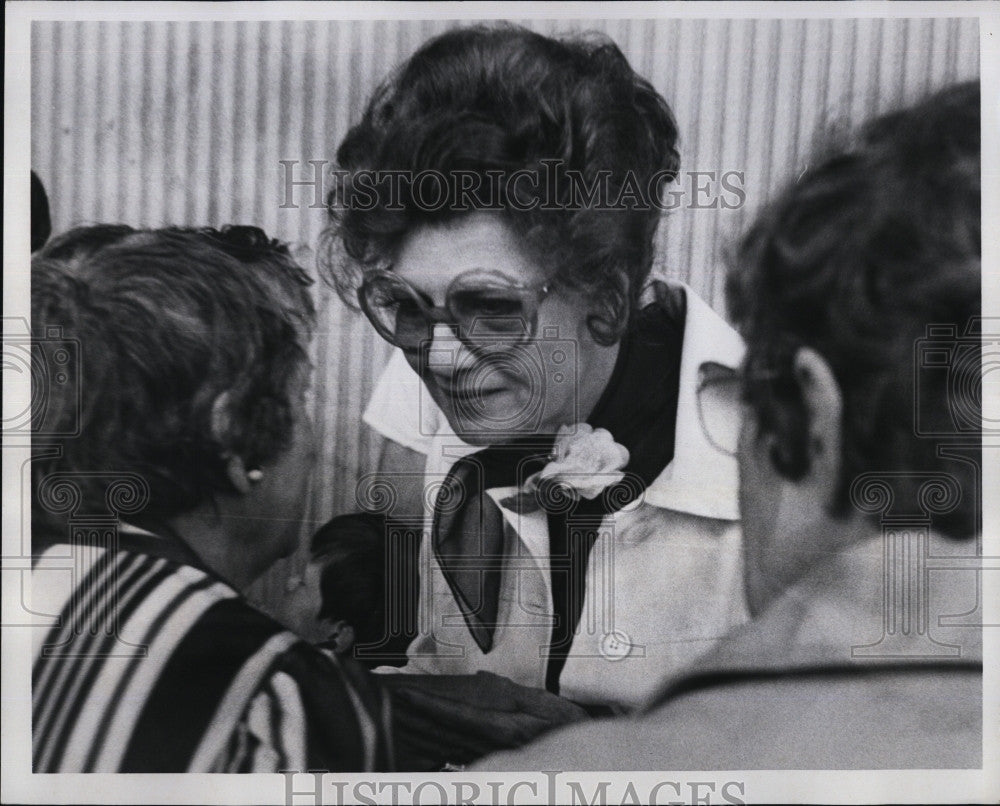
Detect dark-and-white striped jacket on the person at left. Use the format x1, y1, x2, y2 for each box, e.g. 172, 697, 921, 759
32, 530, 391, 773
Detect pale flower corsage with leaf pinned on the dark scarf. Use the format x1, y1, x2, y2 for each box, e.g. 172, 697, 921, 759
500, 423, 629, 513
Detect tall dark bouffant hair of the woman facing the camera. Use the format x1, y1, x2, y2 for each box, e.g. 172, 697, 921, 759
321, 25, 679, 344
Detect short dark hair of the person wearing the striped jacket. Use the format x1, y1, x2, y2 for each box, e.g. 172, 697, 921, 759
31, 225, 315, 522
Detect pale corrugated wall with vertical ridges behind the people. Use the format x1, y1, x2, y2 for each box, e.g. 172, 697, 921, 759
31, 19, 979, 602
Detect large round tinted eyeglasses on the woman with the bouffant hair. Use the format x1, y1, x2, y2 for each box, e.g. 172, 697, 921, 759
358, 270, 552, 351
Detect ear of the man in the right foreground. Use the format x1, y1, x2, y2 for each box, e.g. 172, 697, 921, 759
793, 347, 844, 505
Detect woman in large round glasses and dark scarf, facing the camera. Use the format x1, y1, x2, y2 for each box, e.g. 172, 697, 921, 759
326, 26, 745, 728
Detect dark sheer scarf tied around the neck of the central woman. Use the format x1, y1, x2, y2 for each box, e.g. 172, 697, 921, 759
431, 284, 686, 693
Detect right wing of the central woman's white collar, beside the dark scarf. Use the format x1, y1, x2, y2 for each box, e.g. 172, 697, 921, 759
645, 281, 745, 521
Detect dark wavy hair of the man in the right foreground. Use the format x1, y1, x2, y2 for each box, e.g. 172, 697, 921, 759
727, 83, 981, 537
